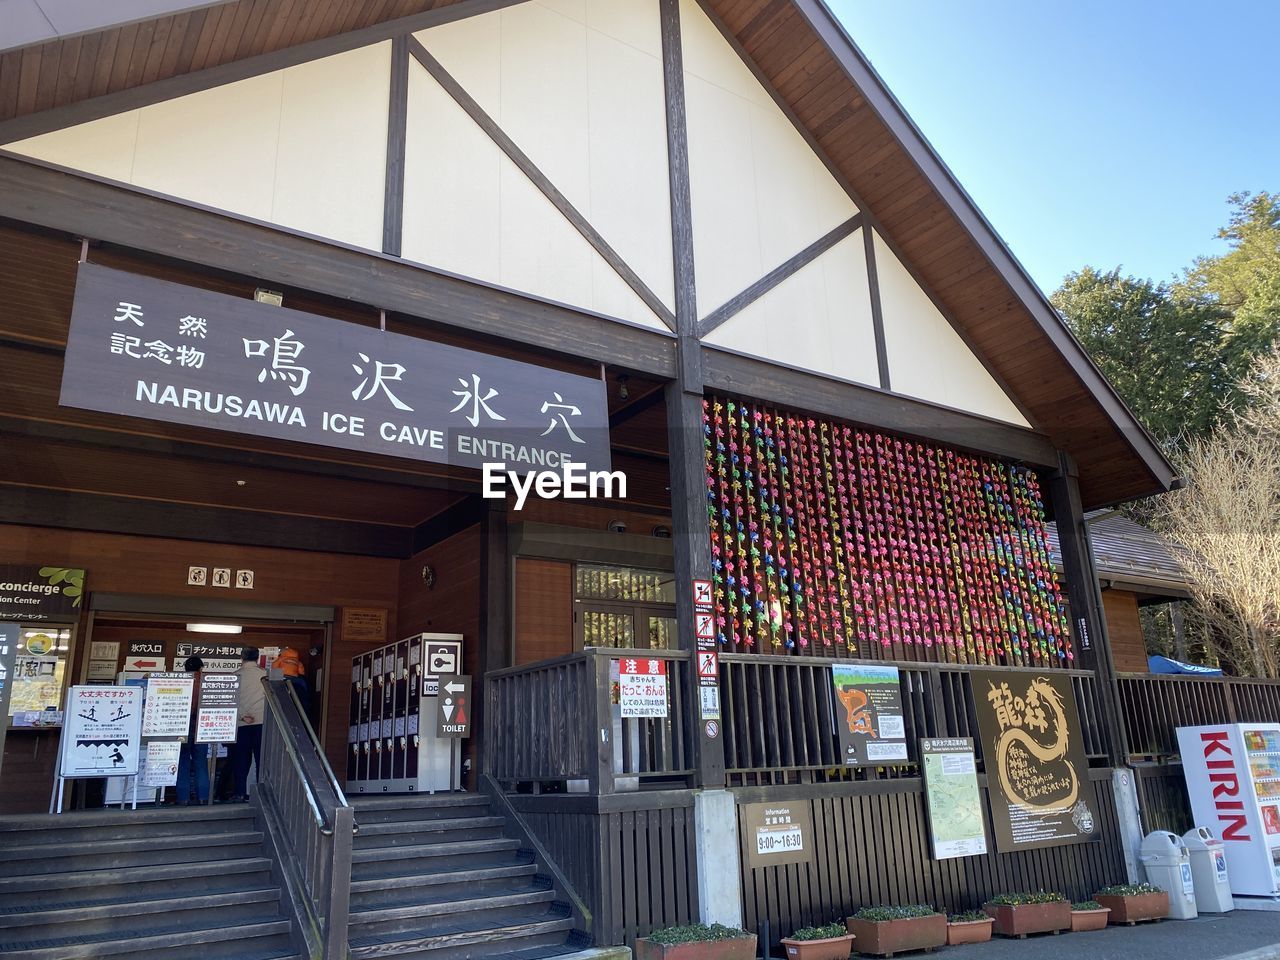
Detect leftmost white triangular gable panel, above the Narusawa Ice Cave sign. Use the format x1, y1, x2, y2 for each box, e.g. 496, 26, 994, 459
8, 44, 390, 250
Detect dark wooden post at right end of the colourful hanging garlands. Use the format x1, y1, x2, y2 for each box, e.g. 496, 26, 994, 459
1048, 452, 1129, 767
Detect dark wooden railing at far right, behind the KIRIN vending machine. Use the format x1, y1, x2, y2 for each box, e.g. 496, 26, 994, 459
1117, 673, 1280, 762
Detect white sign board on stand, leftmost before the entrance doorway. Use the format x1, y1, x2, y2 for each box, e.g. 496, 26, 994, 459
59, 686, 142, 777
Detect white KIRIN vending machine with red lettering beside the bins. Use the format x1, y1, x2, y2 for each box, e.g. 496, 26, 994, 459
1178, 723, 1280, 897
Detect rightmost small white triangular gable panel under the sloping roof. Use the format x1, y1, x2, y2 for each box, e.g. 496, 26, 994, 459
876, 234, 1029, 426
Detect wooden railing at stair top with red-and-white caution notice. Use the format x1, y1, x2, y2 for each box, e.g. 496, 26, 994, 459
485, 648, 692, 794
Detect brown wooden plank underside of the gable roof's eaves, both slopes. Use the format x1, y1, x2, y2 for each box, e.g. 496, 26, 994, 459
0, 0, 1175, 508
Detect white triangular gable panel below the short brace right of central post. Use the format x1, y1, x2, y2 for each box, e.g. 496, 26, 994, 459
705, 230, 879, 385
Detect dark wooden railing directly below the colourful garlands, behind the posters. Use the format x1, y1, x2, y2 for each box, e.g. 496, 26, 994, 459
721, 654, 1107, 786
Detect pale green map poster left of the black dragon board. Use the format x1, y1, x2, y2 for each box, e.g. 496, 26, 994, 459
920, 737, 987, 860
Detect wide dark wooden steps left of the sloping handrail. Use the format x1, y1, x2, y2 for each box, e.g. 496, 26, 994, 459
0, 805, 296, 960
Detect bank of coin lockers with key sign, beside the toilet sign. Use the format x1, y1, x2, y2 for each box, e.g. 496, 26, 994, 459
347, 634, 462, 794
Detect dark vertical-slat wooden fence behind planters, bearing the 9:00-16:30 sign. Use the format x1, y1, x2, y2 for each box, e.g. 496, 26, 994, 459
735, 768, 1125, 950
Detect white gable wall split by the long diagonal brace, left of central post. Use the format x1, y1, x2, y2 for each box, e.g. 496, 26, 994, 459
417, 0, 675, 326
